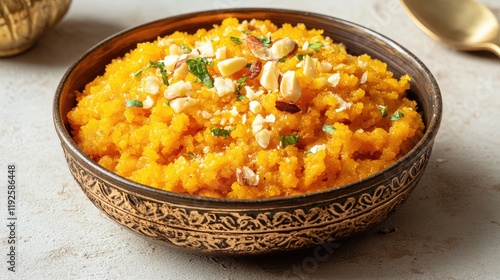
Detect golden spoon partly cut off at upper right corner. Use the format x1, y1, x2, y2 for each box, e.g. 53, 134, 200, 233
401, 0, 500, 57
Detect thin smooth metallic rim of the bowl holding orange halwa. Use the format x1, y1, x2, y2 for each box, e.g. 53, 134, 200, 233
52, 8, 443, 208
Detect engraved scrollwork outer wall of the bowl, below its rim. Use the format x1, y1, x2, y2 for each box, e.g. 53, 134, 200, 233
61, 149, 430, 254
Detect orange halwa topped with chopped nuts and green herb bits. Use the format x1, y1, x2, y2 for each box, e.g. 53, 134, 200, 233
68, 18, 424, 199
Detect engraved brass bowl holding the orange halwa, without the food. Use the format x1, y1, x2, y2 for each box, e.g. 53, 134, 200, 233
53, 8, 442, 255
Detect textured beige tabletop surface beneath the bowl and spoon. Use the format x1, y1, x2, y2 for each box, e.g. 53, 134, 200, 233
0, 0, 500, 279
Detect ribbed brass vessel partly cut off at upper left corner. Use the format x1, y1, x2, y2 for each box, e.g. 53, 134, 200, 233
0, 0, 71, 57
